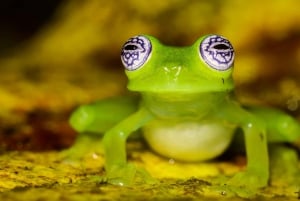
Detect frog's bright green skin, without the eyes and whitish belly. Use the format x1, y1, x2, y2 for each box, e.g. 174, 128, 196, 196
70, 36, 300, 188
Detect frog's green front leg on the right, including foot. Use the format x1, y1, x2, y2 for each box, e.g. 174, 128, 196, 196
217, 102, 269, 189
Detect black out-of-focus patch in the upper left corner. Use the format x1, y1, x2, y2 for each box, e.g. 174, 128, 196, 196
0, 0, 62, 54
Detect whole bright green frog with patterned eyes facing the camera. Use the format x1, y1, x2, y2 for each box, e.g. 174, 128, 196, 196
70, 35, 300, 188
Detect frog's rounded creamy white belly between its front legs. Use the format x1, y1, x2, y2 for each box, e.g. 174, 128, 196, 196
143, 121, 234, 162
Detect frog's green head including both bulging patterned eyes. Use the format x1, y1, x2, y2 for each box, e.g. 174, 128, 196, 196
121, 35, 234, 93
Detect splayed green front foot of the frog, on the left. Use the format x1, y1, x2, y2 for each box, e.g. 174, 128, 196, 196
100, 163, 157, 186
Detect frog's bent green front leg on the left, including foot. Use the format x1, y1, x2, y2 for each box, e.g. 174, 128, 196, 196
102, 108, 153, 186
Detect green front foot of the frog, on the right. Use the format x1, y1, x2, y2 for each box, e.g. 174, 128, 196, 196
226, 170, 269, 189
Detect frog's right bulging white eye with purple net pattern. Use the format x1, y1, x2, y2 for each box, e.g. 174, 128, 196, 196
199, 35, 234, 71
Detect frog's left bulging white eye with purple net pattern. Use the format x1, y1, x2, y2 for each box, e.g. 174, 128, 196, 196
121, 36, 152, 71
